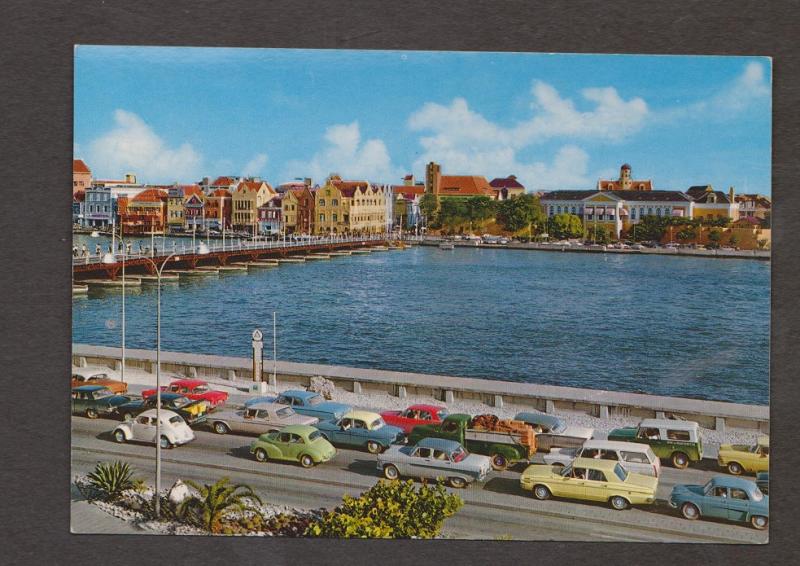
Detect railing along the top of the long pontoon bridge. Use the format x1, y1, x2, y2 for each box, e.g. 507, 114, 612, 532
72, 234, 406, 266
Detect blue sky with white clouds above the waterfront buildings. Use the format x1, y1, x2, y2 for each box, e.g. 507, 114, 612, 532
74, 46, 772, 194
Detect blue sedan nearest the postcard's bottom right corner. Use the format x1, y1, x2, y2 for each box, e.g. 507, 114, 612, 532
669, 476, 769, 530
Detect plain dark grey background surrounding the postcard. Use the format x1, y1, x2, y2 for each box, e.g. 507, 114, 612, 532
0, 0, 800, 564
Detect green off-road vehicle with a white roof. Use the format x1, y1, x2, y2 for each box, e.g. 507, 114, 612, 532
608, 419, 703, 469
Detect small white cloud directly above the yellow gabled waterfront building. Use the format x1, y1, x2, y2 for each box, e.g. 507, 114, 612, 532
284, 122, 402, 182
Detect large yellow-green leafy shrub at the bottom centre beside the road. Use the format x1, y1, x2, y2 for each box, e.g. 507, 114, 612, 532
305, 480, 464, 539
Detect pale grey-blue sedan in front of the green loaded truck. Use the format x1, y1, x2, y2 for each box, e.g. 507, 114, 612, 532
377, 438, 492, 488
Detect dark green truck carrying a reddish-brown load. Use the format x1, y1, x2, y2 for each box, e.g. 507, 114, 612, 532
408, 413, 536, 470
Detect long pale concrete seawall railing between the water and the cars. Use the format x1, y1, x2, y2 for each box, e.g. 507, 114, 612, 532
72, 344, 769, 432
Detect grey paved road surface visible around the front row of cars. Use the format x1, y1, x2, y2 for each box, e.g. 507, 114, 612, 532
72, 417, 768, 543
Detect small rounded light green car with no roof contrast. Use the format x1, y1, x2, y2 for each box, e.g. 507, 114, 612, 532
250, 425, 336, 468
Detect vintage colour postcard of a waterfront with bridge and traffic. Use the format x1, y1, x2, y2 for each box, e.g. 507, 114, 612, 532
70, 45, 772, 544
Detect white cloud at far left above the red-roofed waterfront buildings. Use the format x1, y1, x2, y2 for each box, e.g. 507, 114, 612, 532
89, 110, 202, 183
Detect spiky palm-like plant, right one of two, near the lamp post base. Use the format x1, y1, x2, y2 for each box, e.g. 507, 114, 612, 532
178, 478, 263, 533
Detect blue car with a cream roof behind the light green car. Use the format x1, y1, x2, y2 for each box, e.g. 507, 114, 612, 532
317, 411, 405, 454
